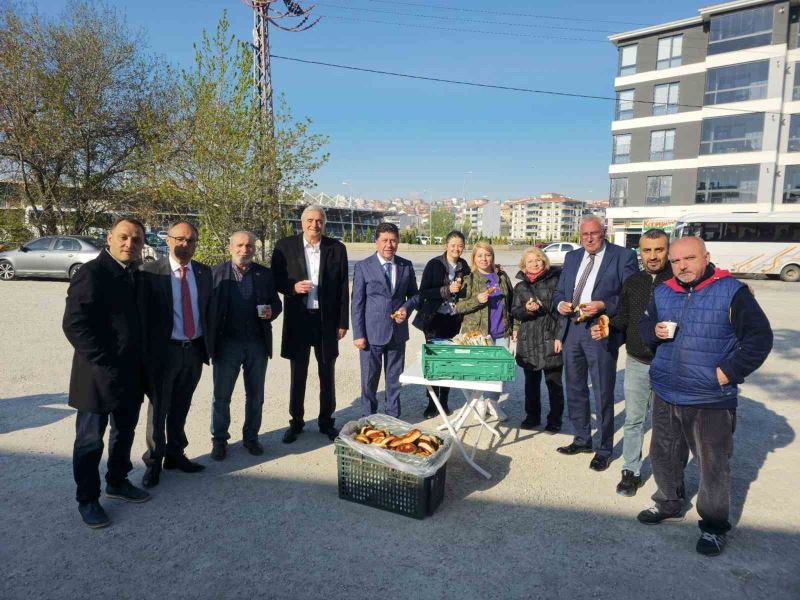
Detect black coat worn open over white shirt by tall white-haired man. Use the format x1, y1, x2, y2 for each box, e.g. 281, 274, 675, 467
272, 234, 350, 360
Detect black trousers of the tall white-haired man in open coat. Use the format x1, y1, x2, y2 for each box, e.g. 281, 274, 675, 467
284, 312, 336, 430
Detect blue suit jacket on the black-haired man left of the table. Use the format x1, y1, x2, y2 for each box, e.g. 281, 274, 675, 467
353, 254, 419, 346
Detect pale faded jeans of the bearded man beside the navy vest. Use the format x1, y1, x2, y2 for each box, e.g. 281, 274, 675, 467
622, 356, 653, 476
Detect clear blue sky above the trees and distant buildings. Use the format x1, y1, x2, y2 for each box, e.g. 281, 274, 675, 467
33, 0, 706, 200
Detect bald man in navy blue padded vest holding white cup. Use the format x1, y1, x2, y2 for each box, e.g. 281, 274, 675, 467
638, 237, 772, 556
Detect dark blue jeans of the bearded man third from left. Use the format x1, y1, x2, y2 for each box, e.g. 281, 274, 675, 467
211, 340, 268, 442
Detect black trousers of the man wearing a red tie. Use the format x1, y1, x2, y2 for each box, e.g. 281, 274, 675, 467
142, 340, 203, 467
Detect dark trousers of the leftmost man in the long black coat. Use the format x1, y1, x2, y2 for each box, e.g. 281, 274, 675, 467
72, 402, 142, 502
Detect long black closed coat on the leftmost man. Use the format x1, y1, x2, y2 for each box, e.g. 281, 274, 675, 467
62, 250, 143, 413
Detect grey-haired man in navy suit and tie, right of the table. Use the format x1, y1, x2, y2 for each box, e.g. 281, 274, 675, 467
553, 216, 639, 471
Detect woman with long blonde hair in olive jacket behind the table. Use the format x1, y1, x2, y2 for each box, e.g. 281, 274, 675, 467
455, 240, 514, 420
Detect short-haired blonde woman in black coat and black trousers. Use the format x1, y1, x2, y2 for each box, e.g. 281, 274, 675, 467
511, 248, 564, 433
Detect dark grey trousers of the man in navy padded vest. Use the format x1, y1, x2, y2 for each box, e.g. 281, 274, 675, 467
650, 395, 736, 534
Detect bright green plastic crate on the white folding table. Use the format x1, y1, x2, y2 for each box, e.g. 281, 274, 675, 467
422, 344, 517, 381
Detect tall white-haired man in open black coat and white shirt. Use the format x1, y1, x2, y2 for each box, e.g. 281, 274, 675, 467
272, 206, 350, 444
